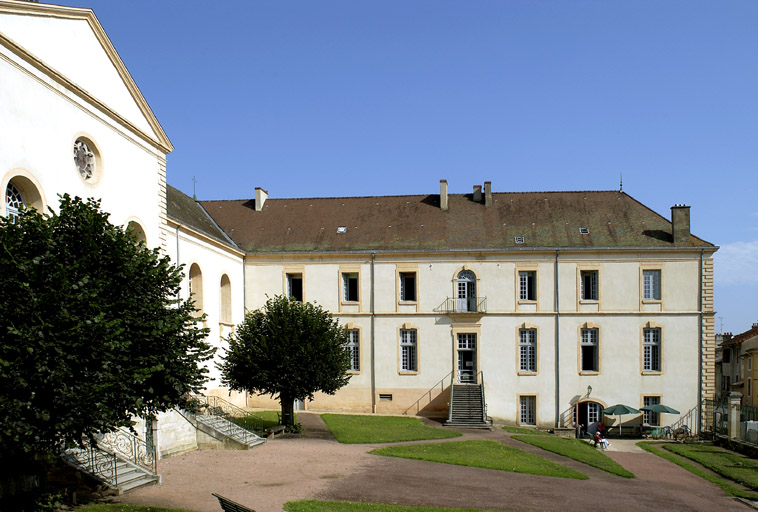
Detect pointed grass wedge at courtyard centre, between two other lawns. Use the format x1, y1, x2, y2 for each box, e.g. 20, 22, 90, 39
370, 436, 587, 480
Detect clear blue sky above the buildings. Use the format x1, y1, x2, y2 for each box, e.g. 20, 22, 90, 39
59, 0, 758, 333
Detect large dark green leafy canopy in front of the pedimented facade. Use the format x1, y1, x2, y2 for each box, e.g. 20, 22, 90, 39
0, 195, 214, 455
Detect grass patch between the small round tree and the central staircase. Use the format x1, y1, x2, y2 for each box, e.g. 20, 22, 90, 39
321, 414, 461, 444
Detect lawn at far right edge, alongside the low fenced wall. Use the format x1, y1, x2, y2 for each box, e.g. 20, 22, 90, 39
663, 443, 758, 490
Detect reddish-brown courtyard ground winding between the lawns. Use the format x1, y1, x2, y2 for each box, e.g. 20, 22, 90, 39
117, 413, 751, 512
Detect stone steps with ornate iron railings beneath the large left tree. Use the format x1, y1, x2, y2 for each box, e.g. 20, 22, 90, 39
61, 430, 161, 494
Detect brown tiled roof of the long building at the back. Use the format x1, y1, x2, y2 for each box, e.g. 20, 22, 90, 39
200, 191, 713, 253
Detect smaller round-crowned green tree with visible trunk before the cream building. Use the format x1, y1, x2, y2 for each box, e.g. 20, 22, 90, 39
219, 296, 350, 426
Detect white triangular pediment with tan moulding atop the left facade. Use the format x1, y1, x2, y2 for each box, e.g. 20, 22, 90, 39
0, 0, 173, 153
